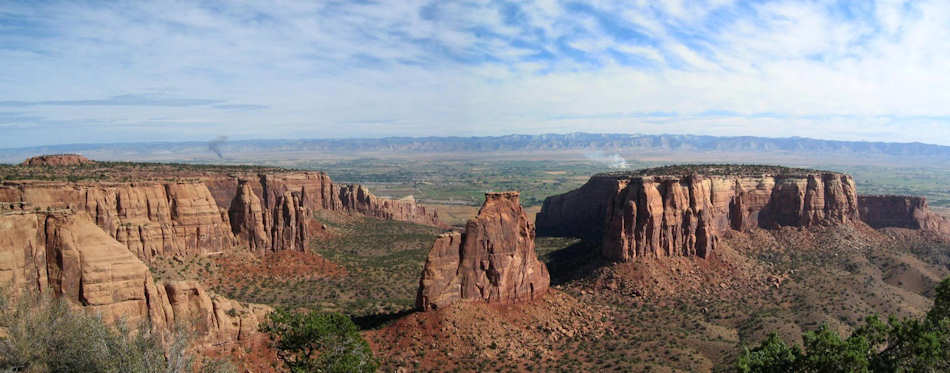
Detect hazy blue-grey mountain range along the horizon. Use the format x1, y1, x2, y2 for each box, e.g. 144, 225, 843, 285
0, 133, 950, 163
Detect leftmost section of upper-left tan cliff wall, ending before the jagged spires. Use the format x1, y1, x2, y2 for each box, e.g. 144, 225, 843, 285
0, 182, 235, 262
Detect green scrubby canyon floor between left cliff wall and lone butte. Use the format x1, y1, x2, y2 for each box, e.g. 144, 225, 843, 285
197, 214, 441, 317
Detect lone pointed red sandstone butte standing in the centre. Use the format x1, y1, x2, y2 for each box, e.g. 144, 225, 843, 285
416, 192, 550, 311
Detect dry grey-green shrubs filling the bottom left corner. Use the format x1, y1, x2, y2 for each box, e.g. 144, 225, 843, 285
0, 294, 229, 373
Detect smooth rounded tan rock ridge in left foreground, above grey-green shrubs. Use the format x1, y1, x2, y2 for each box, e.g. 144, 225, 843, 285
0, 211, 269, 343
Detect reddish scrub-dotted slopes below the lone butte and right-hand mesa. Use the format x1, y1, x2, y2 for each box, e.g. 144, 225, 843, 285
365, 225, 950, 372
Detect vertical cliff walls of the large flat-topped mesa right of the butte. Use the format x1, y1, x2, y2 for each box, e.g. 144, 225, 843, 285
537, 171, 859, 262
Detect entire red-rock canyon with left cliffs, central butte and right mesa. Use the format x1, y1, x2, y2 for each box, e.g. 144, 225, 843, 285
0, 161, 950, 371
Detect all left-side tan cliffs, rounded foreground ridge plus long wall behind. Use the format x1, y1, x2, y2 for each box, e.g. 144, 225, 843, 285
0, 157, 441, 343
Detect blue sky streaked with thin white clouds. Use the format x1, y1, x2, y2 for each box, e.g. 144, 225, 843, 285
0, 0, 950, 148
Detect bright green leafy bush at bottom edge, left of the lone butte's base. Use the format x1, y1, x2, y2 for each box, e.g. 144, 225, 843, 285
260, 309, 379, 373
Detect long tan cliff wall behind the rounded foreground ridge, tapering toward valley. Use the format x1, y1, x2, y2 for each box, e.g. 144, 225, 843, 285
0, 172, 439, 262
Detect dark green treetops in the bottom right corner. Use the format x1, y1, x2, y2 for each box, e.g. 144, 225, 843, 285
736, 278, 950, 372
